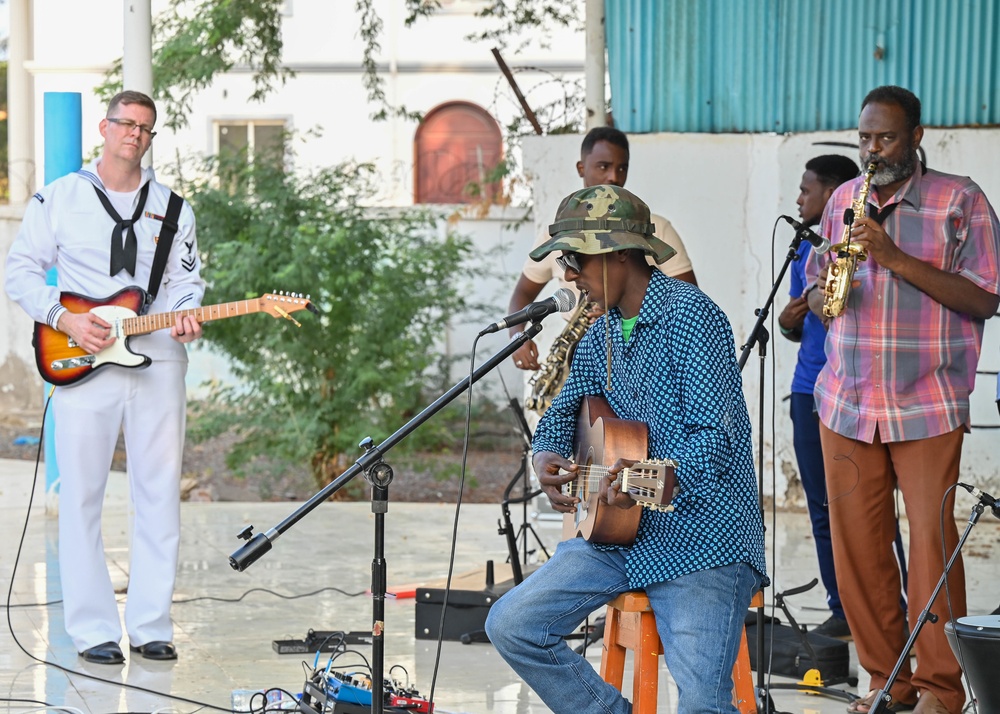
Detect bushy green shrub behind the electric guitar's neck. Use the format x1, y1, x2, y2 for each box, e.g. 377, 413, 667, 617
178, 149, 470, 483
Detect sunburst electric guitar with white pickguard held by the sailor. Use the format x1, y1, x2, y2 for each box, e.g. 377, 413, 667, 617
32, 287, 316, 387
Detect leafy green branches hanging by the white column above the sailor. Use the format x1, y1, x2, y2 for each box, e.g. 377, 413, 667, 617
97, 0, 294, 129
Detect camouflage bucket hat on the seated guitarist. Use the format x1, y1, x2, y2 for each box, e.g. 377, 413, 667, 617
529, 185, 676, 263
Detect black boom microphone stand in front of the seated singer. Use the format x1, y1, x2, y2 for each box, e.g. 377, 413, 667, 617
229, 316, 544, 714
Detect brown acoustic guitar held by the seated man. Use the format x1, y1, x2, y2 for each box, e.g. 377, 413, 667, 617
563, 396, 677, 545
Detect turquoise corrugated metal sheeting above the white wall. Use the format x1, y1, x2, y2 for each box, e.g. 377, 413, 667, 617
605, 0, 1000, 133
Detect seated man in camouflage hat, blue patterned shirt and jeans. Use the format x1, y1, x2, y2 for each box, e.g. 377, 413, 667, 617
486, 185, 767, 714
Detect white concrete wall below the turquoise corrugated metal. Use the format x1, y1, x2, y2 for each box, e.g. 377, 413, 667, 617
524, 129, 1000, 510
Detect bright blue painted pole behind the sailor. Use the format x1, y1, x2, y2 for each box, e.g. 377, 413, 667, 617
44, 92, 83, 501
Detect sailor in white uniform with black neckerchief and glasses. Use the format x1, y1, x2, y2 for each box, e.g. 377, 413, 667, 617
5, 92, 205, 664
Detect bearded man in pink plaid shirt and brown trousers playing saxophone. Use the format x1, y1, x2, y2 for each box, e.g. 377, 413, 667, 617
807, 86, 1000, 714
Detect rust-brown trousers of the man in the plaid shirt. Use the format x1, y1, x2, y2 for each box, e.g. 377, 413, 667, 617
820, 424, 966, 714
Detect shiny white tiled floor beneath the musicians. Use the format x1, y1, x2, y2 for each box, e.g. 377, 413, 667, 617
0, 461, 1000, 714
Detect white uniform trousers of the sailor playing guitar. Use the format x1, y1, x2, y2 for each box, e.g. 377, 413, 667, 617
52, 361, 187, 652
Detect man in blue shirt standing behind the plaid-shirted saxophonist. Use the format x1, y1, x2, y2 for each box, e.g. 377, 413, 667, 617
778, 154, 858, 638
